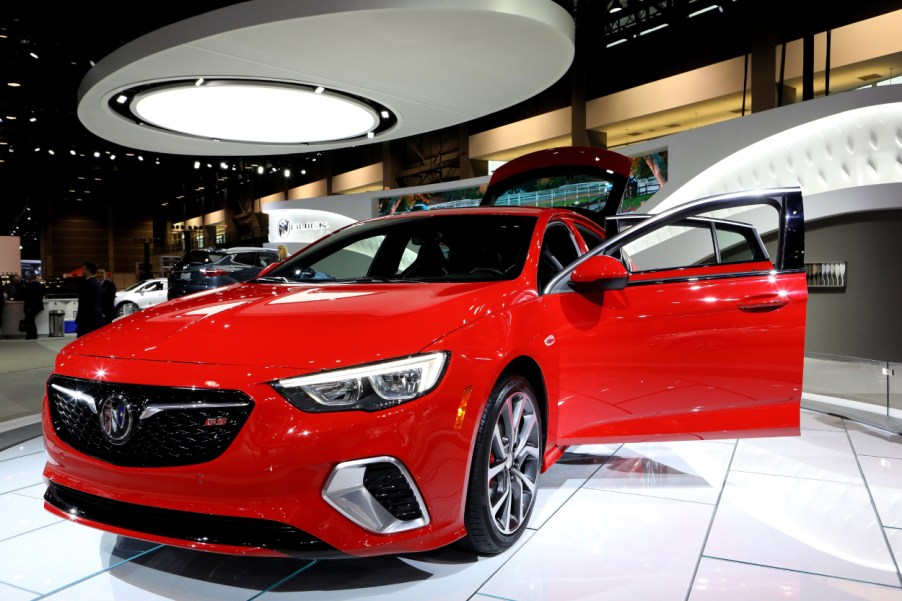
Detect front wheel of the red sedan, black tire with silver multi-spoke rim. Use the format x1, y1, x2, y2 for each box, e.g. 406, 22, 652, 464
462, 375, 543, 555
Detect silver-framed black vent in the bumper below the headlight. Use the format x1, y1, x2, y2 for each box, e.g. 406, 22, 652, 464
323, 456, 429, 534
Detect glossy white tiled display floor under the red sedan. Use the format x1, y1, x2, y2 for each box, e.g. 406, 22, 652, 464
0, 411, 902, 601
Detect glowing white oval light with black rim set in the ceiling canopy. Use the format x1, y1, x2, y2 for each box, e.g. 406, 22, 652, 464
121, 77, 388, 145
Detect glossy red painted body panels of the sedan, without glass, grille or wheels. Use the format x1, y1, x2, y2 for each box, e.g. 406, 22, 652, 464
43, 158, 807, 556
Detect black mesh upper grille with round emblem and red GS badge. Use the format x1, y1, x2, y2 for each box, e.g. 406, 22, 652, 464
47, 375, 254, 467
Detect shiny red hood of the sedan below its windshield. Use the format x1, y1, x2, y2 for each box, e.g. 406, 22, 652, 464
63, 281, 535, 372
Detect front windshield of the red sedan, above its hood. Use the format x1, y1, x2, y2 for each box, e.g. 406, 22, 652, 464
262, 214, 536, 282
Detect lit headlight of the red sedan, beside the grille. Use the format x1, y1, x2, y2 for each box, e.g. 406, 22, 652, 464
270, 352, 448, 412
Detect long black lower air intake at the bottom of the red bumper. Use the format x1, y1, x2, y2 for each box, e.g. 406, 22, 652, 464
44, 482, 343, 558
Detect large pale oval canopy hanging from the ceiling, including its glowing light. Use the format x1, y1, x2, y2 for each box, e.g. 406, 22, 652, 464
78, 0, 575, 157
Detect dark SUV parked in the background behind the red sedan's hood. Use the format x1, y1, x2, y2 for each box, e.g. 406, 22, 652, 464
167, 247, 279, 300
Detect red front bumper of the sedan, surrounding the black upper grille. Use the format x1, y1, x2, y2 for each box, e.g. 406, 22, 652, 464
44, 356, 488, 557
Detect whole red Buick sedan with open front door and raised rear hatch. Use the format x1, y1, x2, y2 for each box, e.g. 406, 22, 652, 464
43, 148, 807, 557
